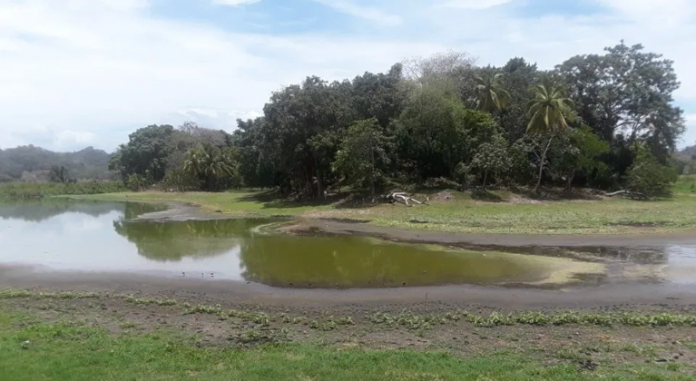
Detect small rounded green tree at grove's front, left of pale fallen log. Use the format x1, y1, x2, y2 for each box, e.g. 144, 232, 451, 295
333, 118, 389, 197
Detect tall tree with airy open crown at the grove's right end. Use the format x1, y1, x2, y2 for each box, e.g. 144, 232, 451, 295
556, 41, 684, 163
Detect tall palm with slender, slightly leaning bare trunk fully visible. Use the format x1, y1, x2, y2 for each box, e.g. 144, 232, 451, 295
527, 82, 575, 192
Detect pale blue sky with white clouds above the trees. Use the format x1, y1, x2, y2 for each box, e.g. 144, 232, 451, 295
0, 0, 696, 151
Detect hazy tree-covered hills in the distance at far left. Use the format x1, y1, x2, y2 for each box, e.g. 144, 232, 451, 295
0, 145, 112, 182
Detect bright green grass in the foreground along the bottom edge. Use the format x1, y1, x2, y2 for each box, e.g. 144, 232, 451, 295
0, 311, 691, 381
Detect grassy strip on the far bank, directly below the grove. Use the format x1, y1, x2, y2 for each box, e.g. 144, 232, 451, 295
72, 184, 696, 234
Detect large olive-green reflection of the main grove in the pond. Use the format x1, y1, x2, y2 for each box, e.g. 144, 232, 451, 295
240, 236, 544, 288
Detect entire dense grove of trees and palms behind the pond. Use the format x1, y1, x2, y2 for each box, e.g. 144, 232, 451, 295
103, 42, 685, 198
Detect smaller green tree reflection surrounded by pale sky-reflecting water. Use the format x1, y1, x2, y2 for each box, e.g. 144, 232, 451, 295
114, 219, 260, 261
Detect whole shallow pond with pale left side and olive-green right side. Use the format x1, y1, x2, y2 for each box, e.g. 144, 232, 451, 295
0, 202, 604, 288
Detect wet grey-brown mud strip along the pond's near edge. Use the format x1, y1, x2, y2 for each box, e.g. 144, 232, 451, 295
0, 266, 696, 311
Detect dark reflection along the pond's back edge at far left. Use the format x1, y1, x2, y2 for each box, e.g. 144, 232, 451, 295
0, 199, 125, 222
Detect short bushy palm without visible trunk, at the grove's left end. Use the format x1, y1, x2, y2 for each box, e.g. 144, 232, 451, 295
183, 145, 234, 190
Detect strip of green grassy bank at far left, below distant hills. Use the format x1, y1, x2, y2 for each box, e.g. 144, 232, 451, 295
0, 181, 126, 202
